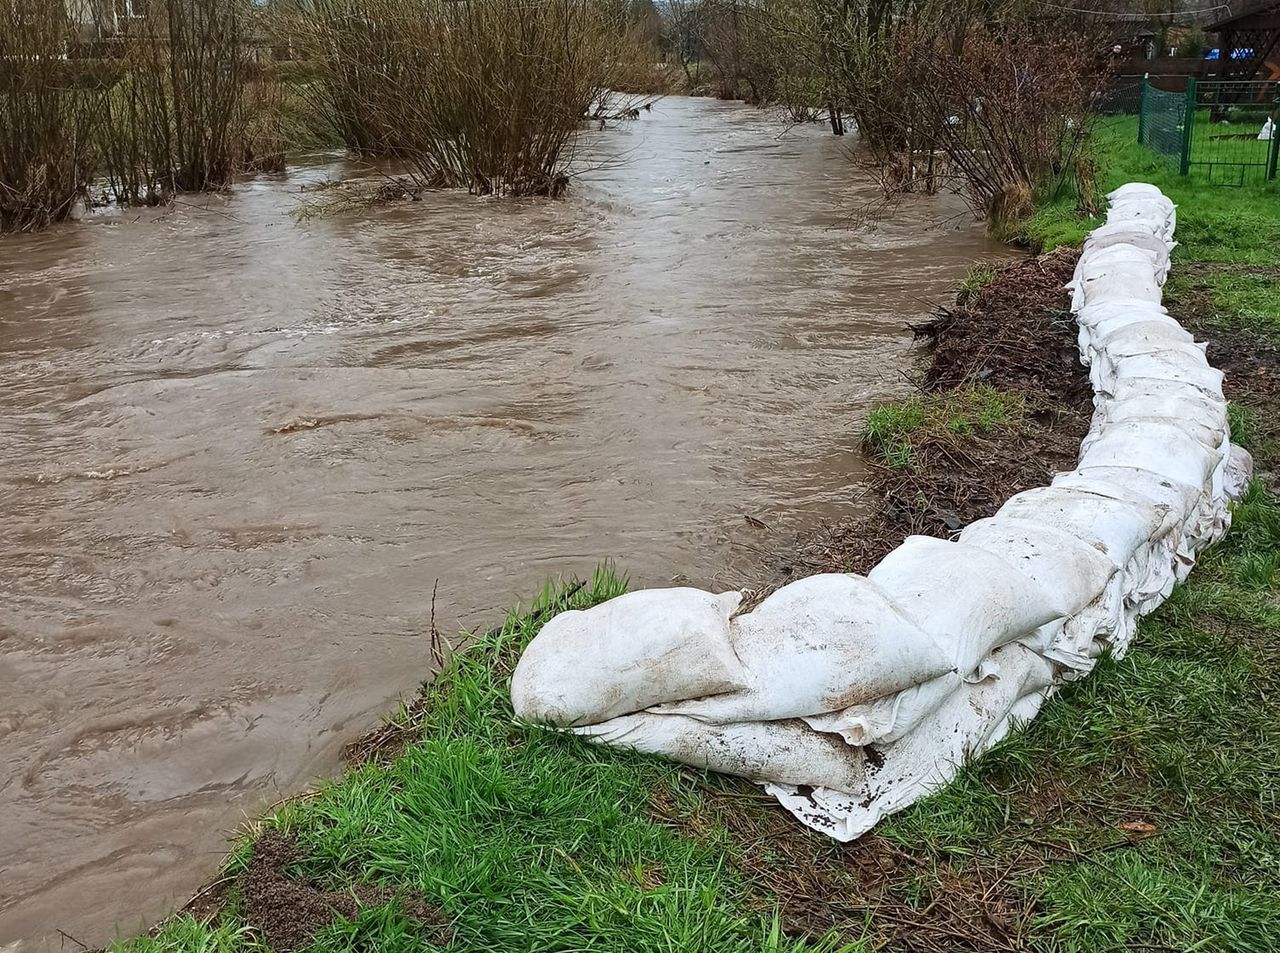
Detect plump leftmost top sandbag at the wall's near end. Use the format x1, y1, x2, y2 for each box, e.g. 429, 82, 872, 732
511, 588, 746, 725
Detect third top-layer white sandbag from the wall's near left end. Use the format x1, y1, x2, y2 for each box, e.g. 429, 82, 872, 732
868, 536, 1069, 675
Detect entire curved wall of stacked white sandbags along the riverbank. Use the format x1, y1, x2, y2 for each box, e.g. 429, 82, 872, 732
512, 184, 1251, 840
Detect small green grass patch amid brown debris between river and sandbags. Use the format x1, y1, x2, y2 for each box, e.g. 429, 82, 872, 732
863, 384, 1027, 469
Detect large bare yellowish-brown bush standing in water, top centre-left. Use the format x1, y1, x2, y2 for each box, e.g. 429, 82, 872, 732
296, 0, 655, 196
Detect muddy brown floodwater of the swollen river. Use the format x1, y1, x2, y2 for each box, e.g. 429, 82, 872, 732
0, 100, 996, 949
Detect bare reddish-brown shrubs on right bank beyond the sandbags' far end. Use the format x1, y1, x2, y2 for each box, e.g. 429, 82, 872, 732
764, 0, 1107, 232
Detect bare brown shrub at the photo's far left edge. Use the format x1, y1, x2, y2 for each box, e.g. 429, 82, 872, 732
0, 0, 109, 232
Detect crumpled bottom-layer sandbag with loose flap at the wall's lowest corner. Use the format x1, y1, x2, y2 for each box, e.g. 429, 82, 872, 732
765, 643, 1055, 840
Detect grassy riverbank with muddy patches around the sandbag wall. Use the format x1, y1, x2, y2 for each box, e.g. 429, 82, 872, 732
118, 128, 1280, 953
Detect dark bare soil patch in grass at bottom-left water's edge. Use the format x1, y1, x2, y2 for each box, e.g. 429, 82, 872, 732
239, 830, 452, 953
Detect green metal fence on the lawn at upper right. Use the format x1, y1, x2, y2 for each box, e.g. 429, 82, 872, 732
1138, 77, 1280, 185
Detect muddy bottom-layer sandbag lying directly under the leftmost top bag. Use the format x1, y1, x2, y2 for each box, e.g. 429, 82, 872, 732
573, 711, 864, 791
